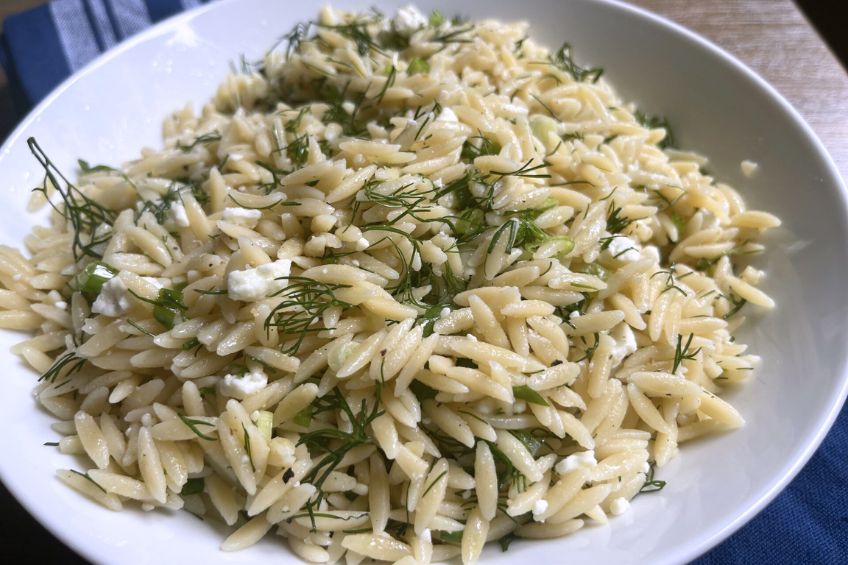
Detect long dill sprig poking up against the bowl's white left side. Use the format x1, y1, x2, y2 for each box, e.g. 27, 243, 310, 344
27, 137, 117, 260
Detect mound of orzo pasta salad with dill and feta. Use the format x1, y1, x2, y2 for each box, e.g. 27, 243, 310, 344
0, 7, 780, 565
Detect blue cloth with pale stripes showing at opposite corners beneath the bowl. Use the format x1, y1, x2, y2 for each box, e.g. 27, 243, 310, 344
0, 0, 848, 565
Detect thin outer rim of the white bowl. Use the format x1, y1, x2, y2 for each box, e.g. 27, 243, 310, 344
0, 0, 848, 563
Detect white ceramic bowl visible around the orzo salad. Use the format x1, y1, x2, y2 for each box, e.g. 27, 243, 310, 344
0, 0, 848, 565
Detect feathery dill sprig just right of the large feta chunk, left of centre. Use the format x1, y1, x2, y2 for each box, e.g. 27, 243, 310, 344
265, 276, 353, 354
